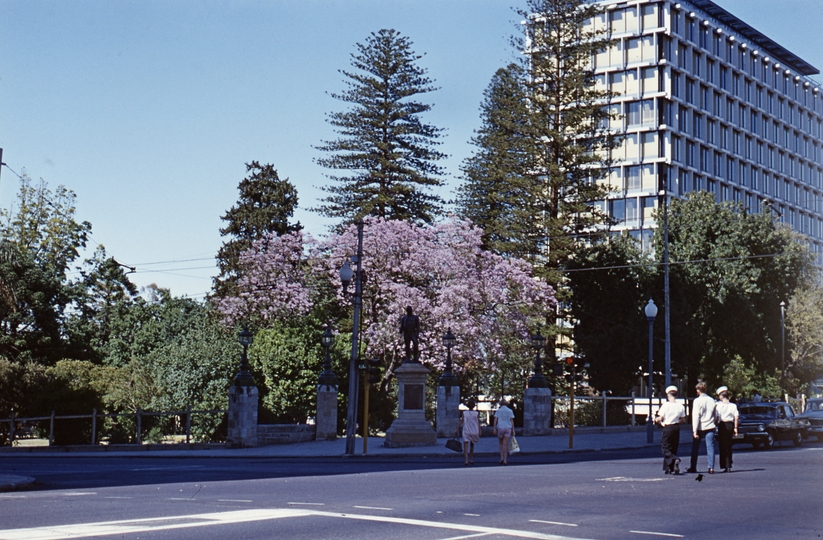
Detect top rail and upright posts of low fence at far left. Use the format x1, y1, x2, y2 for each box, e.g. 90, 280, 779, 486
0, 407, 228, 446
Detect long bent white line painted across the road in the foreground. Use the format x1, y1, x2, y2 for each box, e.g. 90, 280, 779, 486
0, 503, 596, 540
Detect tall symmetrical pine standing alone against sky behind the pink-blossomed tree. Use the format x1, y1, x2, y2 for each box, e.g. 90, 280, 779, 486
316, 30, 445, 225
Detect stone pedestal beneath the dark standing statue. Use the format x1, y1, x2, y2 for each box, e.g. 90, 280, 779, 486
383, 362, 437, 448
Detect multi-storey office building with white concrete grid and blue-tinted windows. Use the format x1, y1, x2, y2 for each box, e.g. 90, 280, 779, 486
590, 0, 823, 262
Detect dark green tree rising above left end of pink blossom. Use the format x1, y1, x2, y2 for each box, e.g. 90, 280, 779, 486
214, 161, 303, 298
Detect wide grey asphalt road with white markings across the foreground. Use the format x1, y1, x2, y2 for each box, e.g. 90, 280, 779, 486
0, 444, 823, 540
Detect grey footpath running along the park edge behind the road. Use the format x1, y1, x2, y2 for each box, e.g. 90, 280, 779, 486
0, 426, 668, 491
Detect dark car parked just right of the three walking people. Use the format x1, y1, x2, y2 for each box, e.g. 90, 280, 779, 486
734, 401, 809, 448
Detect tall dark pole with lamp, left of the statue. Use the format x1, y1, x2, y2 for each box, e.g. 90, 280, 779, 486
340, 219, 363, 456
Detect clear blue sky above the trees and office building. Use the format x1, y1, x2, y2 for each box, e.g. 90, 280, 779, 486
0, 0, 823, 297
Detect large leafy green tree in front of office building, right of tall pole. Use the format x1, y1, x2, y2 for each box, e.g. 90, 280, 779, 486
654, 192, 813, 386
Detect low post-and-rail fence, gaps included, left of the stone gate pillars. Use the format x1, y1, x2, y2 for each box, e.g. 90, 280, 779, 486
0, 407, 228, 446
